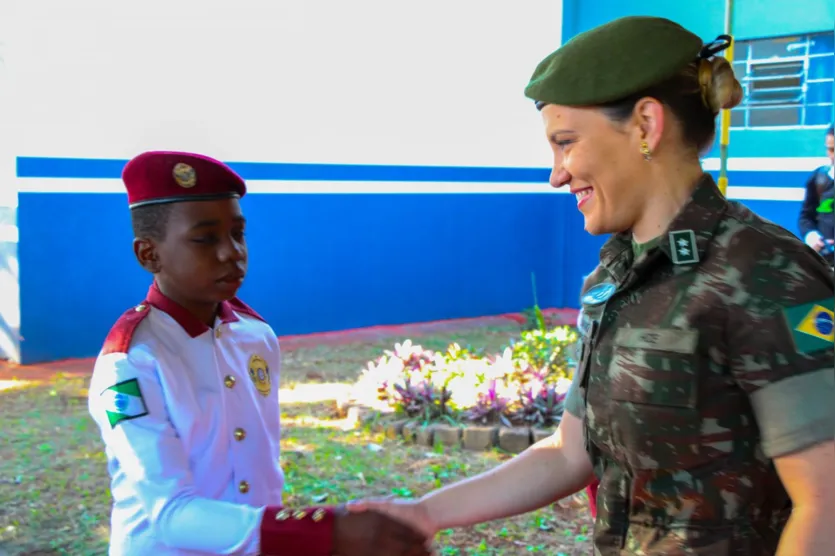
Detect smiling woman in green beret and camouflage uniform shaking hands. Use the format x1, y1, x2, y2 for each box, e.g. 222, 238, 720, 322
353, 17, 835, 556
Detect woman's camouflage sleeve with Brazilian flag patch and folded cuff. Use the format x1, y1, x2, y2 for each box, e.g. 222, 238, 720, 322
728, 230, 835, 458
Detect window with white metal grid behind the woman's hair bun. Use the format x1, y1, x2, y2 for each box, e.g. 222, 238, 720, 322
731, 31, 835, 128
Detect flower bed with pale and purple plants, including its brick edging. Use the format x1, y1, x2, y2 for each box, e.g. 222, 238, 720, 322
342, 320, 578, 452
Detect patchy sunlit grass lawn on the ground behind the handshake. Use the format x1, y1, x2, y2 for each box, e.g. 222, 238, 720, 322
0, 327, 591, 556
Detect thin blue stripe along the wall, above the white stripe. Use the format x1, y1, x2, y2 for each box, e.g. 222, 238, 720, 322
17, 157, 809, 187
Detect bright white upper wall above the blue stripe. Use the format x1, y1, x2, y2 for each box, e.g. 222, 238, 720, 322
5, 0, 562, 167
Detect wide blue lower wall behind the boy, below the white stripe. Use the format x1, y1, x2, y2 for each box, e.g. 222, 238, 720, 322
18, 193, 568, 363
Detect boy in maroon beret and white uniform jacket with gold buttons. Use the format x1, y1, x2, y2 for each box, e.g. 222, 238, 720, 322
88, 152, 427, 556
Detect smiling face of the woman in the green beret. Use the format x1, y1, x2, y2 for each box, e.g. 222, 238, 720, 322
542, 105, 648, 235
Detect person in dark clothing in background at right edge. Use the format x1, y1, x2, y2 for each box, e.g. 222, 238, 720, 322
798, 124, 835, 265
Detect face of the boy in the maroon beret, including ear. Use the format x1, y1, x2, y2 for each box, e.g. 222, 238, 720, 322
134, 199, 247, 311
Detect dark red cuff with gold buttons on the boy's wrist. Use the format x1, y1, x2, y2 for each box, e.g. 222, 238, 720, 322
261, 506, 335, 556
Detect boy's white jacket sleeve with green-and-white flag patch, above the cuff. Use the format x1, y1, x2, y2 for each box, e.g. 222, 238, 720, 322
88, 353, 264, 555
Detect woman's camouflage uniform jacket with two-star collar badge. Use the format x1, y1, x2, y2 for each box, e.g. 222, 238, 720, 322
566, 175, 835, 556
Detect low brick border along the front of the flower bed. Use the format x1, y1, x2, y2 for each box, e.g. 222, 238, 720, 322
345, 406, 554, 454
